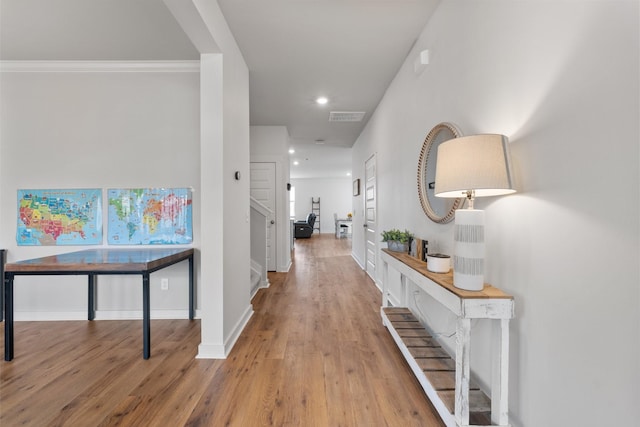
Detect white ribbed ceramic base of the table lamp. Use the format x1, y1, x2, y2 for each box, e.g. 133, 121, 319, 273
453, 209, 484, 291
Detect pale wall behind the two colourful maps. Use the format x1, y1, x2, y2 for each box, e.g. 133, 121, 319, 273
0, 67, 200, 320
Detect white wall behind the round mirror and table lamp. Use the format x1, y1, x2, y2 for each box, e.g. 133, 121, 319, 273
353, 0, 640, 427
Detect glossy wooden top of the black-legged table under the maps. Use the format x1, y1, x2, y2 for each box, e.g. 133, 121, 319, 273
5, 248, 194, 274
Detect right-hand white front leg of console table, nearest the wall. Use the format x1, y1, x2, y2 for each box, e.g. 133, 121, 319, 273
491, 319, 509, 426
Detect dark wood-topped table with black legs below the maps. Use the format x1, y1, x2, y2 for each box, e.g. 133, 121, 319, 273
4, 248, 195, 361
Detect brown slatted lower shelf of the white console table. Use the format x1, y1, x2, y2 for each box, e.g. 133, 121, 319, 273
380, 307, 491, 426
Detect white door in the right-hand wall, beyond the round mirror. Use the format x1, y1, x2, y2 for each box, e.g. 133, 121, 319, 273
364, 154, 377, 281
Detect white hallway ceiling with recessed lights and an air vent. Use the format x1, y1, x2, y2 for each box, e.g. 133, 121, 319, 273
218, 0, 439, 178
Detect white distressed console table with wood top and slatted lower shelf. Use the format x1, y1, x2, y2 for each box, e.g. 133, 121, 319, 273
380, 249, 514, 427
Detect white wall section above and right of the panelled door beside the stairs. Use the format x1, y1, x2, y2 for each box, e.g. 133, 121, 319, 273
247, 126, 291, 272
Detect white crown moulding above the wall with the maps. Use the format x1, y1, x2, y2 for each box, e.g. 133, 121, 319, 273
0, 60, 200, 73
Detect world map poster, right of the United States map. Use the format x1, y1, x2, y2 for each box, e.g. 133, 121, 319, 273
107, 188, 193, 245
